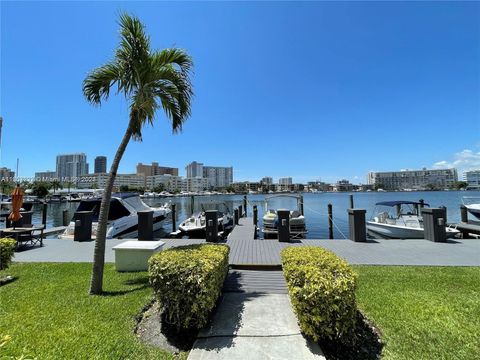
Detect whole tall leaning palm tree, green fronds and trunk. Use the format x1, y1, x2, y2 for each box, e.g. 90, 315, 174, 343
83, 14, 193, 294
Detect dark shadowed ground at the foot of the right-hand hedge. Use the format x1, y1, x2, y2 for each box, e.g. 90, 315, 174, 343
318, 311, 384, 360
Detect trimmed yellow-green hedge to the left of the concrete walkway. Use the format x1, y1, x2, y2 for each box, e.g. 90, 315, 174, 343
149, 244, 230, 330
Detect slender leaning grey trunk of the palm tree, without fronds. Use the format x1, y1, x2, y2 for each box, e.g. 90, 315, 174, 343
90, 121, 132, 295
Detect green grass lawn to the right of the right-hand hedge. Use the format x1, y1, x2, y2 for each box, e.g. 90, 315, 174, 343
354, 266, 480, 360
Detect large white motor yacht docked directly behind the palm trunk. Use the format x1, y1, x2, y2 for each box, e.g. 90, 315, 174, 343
59, 193, 172, 239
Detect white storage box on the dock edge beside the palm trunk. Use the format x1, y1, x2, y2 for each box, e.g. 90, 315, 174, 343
113, 240, 165, 271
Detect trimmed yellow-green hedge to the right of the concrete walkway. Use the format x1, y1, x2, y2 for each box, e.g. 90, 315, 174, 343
281, 246, 357, 341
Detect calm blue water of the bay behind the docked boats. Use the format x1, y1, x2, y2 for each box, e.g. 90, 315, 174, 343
21, 191, 480, 239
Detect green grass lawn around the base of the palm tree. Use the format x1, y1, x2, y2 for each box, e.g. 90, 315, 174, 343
0, 263, 185, 359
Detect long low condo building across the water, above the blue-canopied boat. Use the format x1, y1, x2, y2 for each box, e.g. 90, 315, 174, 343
368, 168, 458, 190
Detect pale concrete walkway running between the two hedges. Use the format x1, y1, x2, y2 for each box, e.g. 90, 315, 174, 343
188, 293, 325, 360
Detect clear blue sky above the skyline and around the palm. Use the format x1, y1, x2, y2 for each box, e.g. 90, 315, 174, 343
0, 1, 480, 183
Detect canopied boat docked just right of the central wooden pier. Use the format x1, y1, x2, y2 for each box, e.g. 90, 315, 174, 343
262, 194, 307, 239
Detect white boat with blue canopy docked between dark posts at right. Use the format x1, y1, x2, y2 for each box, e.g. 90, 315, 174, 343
366, 200, 459, 239
